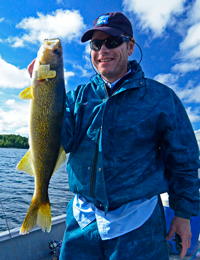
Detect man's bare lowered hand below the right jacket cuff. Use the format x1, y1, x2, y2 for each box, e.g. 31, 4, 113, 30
166, 217, 192, 258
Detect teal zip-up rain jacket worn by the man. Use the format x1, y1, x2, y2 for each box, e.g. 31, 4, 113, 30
61, 61, 200, 219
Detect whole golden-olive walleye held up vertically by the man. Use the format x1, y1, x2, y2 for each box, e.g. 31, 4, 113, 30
17, 39, 66, 235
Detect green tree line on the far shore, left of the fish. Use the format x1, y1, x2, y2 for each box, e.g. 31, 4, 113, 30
0, 134, 29, 149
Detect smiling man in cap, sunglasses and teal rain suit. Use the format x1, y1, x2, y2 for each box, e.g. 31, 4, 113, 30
28, 12, 199, 260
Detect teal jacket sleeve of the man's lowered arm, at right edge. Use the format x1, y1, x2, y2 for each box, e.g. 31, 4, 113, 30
161, 91, 200, 219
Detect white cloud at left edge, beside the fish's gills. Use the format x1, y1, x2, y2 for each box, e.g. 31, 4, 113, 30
0, 57, 31, 88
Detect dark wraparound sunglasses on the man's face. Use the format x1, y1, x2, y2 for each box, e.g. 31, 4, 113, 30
90, 36, 130, 51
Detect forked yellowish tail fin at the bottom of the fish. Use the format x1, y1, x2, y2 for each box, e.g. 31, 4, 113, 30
20, 198, 51, 235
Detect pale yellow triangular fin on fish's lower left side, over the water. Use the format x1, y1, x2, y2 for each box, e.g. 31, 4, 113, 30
17, 149, 35, 176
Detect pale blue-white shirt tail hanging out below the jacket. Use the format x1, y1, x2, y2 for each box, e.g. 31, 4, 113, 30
73, 194, 158, 240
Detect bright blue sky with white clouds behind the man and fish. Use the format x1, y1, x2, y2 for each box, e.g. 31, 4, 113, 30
0, 0, 200, 144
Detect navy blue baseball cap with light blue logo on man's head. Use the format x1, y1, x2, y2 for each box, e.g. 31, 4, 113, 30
81, 12, 133, 42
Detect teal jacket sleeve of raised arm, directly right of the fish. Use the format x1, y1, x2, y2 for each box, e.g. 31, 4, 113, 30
60, 91, 75, 153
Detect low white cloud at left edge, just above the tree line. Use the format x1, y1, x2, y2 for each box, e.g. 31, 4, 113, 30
0, 100, 29, 135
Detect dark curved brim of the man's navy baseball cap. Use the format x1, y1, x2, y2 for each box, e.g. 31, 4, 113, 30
81, 26, 124, 42
